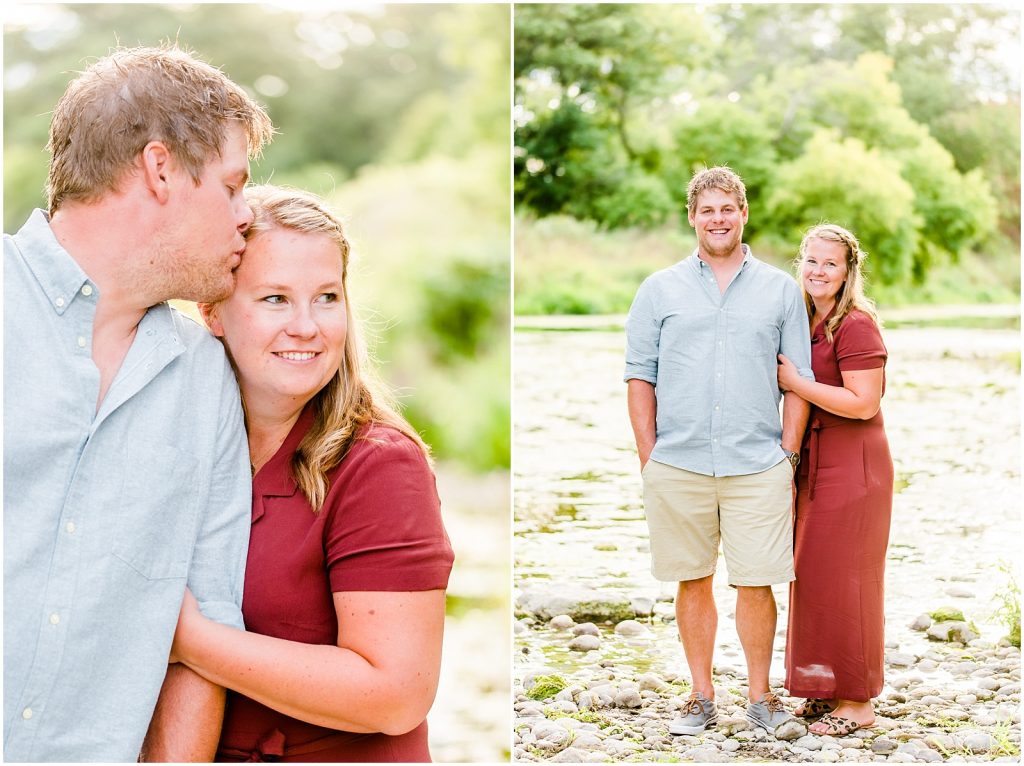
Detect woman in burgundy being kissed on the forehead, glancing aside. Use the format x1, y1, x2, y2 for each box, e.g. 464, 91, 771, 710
171, 186, 453, 762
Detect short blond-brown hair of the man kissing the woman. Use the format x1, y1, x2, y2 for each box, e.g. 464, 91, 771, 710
46, 45, 273, 214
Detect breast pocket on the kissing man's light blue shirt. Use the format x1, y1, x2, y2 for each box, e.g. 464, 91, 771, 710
112, 444, 199, 580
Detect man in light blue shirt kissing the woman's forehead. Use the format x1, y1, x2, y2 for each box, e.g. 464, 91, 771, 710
4, 47, 273, 762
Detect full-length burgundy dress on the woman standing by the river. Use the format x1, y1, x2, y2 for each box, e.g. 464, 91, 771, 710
785, 311, 893, 701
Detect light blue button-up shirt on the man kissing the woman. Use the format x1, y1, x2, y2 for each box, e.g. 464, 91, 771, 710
3, 210, 251, 762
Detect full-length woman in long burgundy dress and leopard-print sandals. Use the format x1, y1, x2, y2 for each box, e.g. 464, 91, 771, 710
778, 223, 893, 736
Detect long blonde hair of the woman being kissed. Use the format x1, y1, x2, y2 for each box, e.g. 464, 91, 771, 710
246, 185, 430, 513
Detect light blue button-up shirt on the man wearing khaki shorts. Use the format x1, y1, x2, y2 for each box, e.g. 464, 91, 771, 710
625, 245, 814, 476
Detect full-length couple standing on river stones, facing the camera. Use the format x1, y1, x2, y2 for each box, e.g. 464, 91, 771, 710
625, 167, 893, 735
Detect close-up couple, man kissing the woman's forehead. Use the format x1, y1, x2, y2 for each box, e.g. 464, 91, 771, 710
4, 47, 453, 762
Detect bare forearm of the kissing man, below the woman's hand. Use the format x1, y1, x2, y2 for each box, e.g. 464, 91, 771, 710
139, 664, 224, 763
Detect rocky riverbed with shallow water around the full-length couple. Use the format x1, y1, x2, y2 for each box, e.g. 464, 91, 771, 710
513, 322, 1021, 762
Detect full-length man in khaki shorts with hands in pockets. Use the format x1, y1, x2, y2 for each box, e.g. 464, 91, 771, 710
625, 167, 812, 734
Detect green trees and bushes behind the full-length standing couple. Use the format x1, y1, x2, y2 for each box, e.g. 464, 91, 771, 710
514, 4, 1020, 301
